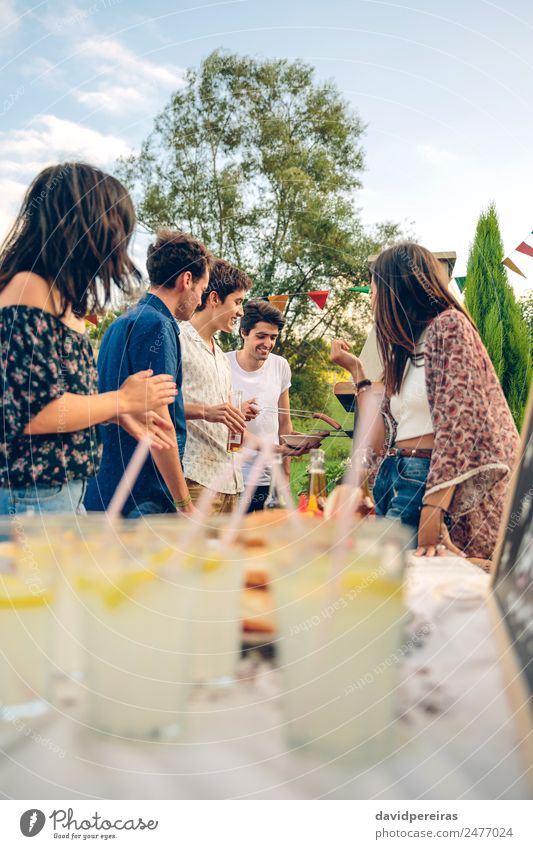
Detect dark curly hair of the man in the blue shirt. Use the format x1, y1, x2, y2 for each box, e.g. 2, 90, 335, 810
146, 230, 212, 289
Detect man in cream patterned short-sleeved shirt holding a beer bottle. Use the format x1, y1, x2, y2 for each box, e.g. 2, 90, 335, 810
180, 259, 252, 513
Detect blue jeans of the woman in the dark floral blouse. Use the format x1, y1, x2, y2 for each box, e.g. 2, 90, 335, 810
0, 481, 86, 516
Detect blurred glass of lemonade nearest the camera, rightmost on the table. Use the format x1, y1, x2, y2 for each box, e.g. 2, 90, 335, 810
272, 520, 408, 763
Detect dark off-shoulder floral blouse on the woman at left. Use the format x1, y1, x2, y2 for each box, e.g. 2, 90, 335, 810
0, 306, 101, 488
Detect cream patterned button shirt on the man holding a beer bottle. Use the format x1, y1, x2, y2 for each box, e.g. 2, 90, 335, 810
180, 321, 244, 494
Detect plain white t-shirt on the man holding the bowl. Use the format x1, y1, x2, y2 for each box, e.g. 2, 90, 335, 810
227, 351, 291, 486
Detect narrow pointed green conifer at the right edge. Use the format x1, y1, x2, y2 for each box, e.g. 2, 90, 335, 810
465, 204, 531, 427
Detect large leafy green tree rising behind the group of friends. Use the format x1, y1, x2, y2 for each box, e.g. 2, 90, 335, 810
119, 51, 399, 406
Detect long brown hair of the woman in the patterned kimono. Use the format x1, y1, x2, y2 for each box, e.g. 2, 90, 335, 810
372, 242, 473, 397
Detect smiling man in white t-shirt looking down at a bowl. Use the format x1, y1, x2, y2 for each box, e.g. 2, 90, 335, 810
227, 300, 292, 512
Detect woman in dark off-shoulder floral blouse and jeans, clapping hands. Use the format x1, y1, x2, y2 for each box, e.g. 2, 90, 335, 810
0, 162, 176, 515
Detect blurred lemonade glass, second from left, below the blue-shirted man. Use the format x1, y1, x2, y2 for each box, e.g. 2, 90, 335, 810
77, 523, 197, 740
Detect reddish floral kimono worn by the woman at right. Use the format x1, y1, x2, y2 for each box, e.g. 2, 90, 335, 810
372, 309, 520, 559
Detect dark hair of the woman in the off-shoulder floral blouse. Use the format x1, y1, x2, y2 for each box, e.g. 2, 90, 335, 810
0, 162, 140, 316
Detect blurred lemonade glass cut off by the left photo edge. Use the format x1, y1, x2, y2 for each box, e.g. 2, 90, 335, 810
0, 517, 53, 721
